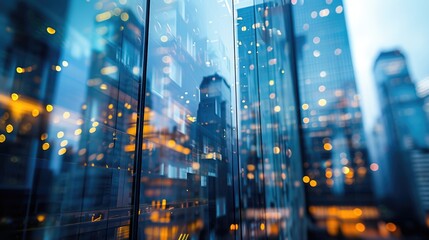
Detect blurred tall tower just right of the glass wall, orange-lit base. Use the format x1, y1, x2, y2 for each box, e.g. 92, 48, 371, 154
292, 0, 378, 236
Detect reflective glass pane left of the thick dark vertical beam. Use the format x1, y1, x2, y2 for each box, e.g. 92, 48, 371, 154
0, 0, 143, 239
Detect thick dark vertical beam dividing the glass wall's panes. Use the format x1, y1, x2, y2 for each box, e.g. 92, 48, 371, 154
130, 0, 150, 239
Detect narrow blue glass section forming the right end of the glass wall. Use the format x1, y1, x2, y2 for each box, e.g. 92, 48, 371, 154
237, 1, 306, 239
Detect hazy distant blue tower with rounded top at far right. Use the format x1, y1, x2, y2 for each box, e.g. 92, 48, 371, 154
374, 50, 429, 227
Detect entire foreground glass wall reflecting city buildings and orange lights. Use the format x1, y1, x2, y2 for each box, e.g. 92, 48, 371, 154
0, 0, 305, 239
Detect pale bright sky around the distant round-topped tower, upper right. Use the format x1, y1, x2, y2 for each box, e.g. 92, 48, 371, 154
342, 0, 429, 130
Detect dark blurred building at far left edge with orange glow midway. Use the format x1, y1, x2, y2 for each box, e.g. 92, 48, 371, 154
0, 1, 69, 238
